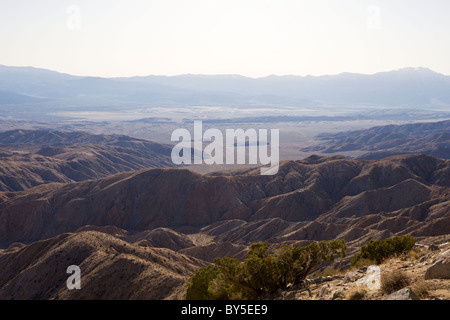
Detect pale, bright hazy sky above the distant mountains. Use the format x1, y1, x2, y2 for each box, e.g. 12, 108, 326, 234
0, 0, 450, 77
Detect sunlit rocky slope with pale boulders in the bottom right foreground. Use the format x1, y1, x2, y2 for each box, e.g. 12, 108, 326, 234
262, 237, 450, 300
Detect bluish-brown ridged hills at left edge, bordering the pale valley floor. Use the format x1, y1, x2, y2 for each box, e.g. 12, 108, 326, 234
0, 130, 174, 191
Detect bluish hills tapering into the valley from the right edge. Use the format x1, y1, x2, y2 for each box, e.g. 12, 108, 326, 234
301, 120, 450, 160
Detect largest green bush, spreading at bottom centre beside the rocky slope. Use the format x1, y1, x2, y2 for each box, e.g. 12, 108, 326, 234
186, 240, 347, 300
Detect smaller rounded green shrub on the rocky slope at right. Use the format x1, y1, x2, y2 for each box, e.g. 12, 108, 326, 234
351, 235, 416, 266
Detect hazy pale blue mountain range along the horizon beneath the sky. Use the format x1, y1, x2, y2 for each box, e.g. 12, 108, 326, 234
0, 66, 450, 108
